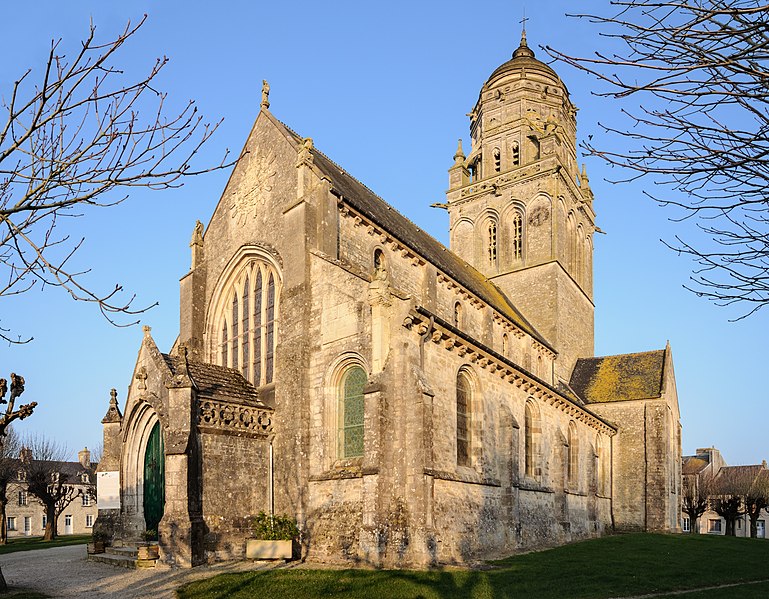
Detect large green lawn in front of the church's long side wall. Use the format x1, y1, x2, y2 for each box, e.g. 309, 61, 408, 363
177, 534, 769, 599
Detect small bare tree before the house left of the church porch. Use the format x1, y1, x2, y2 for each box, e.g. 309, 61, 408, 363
21, 436, 92, 541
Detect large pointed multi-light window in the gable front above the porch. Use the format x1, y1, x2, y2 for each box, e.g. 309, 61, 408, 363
213, 255, 280, 386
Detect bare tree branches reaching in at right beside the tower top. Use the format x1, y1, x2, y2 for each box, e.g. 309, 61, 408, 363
547, 0, 769, 317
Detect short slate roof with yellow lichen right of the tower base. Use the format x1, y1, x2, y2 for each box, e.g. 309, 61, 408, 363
569, 349, 665, 403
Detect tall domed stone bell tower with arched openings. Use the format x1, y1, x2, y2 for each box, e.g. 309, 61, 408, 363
446, 30, 596, 380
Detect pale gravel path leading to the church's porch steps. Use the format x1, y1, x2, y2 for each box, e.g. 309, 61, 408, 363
0, 545, 265, 599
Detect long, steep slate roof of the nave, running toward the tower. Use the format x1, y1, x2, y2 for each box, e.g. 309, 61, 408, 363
281, 123, 555, 351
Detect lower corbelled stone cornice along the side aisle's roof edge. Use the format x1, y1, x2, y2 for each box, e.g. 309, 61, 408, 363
403, 306, 617, 436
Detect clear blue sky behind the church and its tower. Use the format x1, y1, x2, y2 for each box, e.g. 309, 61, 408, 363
0, 0, 769, 464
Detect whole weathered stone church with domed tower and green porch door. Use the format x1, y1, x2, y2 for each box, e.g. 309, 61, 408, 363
98, 34, 681, 567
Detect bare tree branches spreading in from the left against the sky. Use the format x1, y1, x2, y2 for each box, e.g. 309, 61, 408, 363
0, 15, 228, 343
